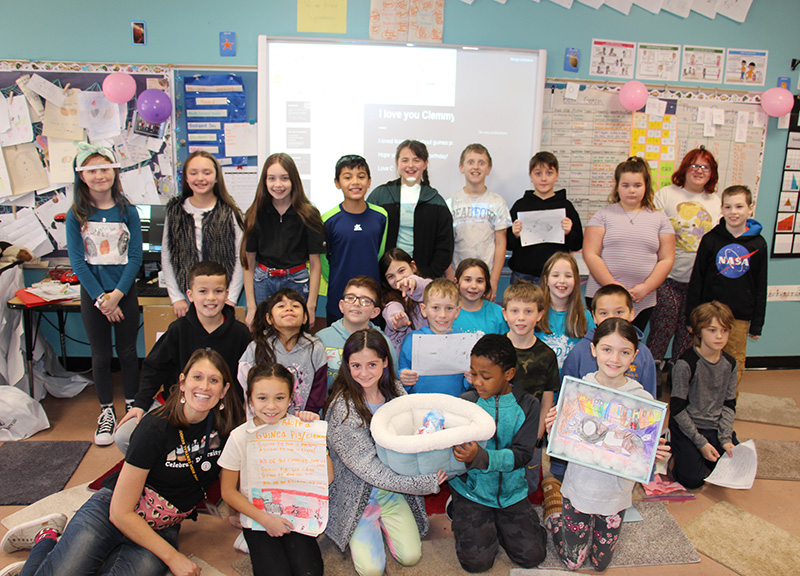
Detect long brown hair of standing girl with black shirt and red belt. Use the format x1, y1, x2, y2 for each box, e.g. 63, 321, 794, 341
239, 152, 325, 270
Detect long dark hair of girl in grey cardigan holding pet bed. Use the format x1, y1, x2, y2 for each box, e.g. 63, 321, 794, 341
323, 328, 399, 427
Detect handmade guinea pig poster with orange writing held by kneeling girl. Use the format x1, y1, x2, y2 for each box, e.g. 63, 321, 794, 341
241, 416, 328, 536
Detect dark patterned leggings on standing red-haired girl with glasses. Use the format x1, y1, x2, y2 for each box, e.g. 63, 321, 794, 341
647, 278, 692, 362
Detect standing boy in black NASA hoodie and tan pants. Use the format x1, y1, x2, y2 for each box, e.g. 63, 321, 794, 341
686, 186, 769, 382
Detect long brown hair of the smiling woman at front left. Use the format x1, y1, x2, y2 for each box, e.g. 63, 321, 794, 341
153, 348, 244, 438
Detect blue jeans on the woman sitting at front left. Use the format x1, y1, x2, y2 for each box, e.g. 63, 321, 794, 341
20, 488, 180, 576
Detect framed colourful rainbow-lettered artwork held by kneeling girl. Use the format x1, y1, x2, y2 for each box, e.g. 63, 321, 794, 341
547, 376, 667, 484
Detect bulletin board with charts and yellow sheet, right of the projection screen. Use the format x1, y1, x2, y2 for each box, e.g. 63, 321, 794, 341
541, 81, 767, 225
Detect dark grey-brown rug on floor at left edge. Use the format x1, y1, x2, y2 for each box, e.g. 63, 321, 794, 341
0, 441, 92, 506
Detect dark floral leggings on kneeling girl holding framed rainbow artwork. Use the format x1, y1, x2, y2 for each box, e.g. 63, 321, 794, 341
553, 498, 625, 572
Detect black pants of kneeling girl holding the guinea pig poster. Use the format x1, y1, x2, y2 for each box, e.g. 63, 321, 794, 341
242, 528, 323, 576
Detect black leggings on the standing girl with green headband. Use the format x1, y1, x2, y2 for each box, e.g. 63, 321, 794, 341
81, 284, 139, 404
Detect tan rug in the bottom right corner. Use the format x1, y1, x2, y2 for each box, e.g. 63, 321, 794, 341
683, 501, 800, 576
